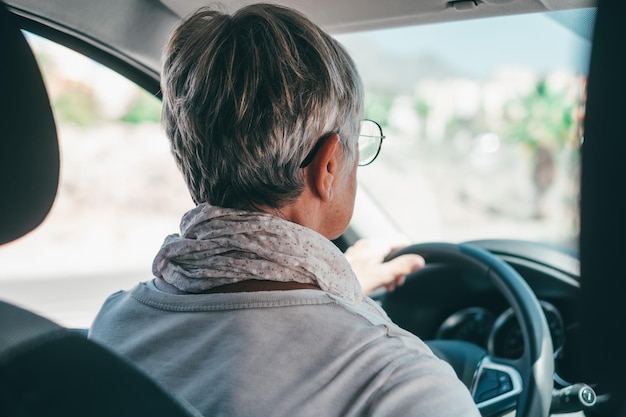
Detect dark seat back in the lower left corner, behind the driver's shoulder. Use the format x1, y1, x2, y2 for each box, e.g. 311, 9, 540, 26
0, 302, 200, 417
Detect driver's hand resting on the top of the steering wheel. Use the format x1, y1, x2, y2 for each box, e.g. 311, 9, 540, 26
345, 239, 425, 295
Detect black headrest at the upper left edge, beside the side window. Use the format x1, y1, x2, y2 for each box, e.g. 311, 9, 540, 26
0, 2, 59, 245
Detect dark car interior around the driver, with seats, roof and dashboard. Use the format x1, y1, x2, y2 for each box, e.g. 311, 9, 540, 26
0, 0, 626, 417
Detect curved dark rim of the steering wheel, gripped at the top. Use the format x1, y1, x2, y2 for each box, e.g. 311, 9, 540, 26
386, 242, 554, 417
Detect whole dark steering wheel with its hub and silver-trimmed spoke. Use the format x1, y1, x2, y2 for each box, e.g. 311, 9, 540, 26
386, 243, 554, 417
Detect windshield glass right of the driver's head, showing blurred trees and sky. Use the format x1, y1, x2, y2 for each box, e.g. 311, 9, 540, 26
337, 10, 594, 248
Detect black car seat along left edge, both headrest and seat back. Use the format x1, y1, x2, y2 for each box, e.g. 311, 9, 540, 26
0, 2, 201, 417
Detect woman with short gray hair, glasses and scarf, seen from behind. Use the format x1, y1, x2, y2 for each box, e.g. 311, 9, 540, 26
90, 4, 479, 417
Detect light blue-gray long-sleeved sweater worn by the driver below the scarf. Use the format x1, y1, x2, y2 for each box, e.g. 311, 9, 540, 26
90, 283, 480, 417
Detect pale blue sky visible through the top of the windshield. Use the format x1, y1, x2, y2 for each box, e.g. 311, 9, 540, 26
337, 11, 591, 79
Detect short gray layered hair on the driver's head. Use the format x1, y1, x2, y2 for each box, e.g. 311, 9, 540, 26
161, 4, 363, 210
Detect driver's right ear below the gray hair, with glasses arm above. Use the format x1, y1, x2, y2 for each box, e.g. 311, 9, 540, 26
305, 133, 343, 202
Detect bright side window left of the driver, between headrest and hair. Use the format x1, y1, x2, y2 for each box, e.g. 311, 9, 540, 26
0, 34, 193, 327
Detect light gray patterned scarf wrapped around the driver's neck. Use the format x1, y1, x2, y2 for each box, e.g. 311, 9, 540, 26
152, 204, 363, 304
